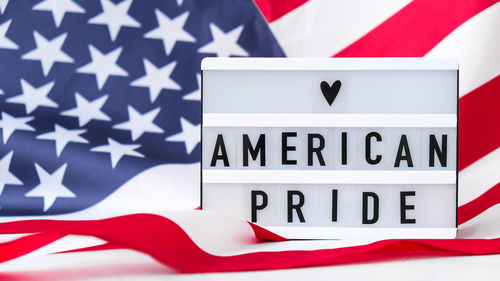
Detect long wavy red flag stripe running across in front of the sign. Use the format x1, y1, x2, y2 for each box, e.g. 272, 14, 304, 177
0, 214, 500, 273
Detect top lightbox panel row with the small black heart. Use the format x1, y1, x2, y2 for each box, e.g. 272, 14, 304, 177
203, 70, 457, 114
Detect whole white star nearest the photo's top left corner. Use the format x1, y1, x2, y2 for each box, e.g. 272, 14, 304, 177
21, 31, 74, 76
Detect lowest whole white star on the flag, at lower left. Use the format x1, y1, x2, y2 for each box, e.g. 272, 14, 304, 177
25, 163, 76, 212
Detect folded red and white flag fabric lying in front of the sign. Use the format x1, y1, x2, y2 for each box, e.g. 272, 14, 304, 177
0, 205, 500, 273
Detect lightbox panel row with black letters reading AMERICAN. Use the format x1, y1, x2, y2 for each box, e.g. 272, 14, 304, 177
202, 127, 457, 170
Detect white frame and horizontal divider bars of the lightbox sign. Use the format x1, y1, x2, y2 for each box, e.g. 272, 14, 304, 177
200, 58, 459, 239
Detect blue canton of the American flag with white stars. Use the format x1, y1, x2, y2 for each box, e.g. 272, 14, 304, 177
0, 0, 283, 215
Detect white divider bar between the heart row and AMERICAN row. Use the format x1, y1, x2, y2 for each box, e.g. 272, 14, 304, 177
203, 113, 457, 128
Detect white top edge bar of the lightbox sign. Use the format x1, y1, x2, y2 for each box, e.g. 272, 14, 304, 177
201, 58, 458, 70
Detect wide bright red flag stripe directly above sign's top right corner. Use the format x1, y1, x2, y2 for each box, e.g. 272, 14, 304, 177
335, 0, 498, 57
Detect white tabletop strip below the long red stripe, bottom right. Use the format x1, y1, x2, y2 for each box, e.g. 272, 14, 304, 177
179, 255, 500, 281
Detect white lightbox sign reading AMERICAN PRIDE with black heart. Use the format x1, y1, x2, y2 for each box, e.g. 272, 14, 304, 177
201, 58, 458, 239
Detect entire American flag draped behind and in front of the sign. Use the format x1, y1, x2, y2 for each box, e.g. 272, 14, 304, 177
0, 0, 500, 280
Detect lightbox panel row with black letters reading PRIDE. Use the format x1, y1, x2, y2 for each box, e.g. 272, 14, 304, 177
203, 183, 456, 228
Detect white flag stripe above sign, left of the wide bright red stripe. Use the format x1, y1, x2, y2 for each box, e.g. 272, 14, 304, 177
270, 0, 410, 57
